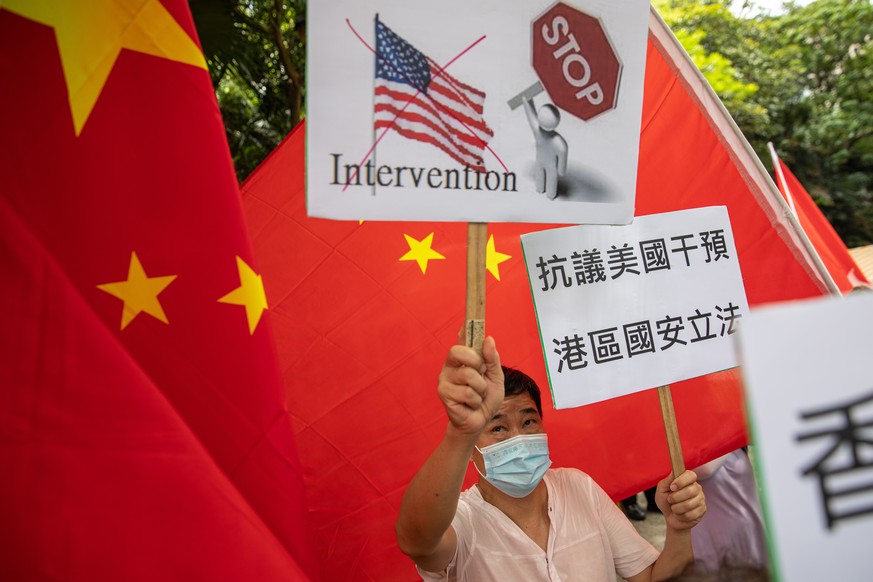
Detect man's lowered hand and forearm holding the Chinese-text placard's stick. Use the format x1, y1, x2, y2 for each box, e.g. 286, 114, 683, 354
628, 471, 706, 582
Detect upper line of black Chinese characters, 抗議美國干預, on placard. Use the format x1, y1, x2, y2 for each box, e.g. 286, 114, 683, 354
536, 229, 730, 291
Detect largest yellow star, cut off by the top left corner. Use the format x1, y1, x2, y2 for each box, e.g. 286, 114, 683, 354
0, 0, 206, 136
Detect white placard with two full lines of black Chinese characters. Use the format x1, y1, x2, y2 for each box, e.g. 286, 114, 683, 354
521, 206, 749, 408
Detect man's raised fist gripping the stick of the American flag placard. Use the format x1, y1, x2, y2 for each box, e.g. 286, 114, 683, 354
437, 337, 503, 435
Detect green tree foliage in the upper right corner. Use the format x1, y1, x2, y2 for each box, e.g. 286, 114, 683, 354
655, 0, 873, 246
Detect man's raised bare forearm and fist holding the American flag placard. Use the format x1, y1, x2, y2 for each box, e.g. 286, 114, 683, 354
394, 338, 503, 572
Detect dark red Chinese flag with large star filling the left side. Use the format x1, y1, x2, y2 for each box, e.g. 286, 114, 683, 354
0, 0, 318, 581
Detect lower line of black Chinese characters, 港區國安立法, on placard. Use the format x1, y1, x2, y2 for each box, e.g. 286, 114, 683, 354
552, 302, 743, 372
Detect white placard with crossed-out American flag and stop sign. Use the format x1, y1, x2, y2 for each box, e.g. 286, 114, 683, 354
306, 0, 650, 224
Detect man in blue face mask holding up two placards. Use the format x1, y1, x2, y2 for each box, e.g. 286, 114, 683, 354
395, 337, 706, 582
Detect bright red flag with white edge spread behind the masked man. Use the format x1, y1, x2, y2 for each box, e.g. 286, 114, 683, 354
243, 9, 826, 581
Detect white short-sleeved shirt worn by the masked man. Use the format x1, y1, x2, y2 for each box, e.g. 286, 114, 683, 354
418, 469, 658, 582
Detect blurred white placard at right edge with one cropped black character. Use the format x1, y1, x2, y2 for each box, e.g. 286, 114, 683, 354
739, 293, 873, 582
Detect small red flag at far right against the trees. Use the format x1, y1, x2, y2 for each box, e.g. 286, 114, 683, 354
774, 158, 869, 293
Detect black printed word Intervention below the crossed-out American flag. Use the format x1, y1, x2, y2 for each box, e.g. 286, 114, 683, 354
330, 154, 518, 192
